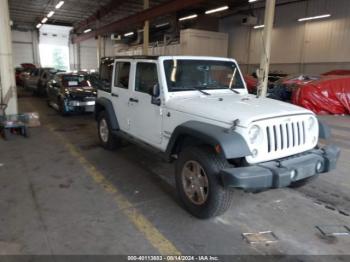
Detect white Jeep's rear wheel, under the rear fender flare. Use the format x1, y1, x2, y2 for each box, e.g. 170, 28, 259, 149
97, 111, 120, 150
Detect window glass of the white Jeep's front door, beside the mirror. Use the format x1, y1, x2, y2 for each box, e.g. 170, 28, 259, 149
135, 63, 158, 94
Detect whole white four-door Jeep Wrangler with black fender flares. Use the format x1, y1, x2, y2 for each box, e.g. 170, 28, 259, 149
95, 56, 340, 218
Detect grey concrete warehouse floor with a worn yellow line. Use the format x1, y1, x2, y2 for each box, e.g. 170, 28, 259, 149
0, 91, 350, 256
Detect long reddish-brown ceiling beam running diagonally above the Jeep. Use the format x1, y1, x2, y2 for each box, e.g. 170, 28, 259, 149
73, 0, 205, 43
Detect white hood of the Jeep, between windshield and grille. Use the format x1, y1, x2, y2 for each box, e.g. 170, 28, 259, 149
167, 93, 313, 127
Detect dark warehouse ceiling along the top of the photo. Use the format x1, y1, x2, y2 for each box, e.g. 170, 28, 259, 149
9, 0, 306, 38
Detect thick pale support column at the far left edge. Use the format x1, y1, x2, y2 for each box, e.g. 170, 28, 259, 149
0, 0, 18, 114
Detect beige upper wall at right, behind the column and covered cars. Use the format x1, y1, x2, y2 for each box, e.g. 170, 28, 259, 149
220, 0, 350, 74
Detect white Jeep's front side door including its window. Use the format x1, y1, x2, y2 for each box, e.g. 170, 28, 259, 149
129, 61, 162, 145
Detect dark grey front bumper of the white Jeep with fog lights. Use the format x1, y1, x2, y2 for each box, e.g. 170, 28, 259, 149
220, 145, 340, 190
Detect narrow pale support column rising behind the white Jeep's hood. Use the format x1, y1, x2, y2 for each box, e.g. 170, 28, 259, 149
257, 0, 276, 97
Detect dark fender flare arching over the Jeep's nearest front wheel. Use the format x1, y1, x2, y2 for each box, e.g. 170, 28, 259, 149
166, 121, 251, 159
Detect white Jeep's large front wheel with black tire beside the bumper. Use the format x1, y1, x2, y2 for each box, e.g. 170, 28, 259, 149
175, 147, 233, 219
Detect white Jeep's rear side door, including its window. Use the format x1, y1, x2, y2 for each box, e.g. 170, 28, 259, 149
111, 60, 132, 131
